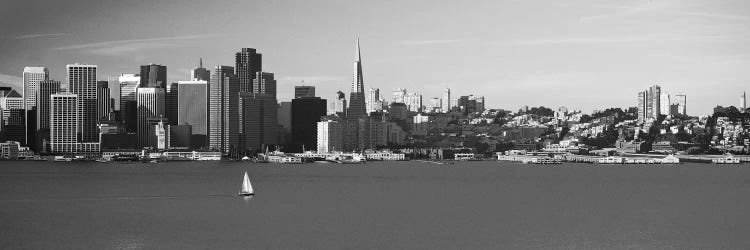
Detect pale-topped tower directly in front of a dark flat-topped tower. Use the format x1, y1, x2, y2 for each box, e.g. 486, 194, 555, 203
136, 87, 165, 147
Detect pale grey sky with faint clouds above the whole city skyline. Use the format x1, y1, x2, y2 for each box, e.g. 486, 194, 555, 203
0, 0, 750, 115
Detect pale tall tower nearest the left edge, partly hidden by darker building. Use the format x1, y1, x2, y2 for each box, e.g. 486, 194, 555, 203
21, 67, 49, 145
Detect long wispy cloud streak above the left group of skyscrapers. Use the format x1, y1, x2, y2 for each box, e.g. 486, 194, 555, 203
54, 35, 216, 56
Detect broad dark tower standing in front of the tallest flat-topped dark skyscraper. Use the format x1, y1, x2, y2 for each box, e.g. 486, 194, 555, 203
239, 92, 279, 150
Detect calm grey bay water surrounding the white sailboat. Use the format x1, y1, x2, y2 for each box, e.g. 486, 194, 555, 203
0, 161, 750, 249
